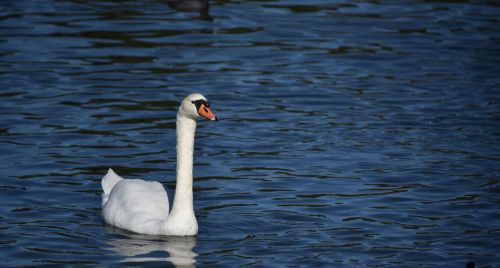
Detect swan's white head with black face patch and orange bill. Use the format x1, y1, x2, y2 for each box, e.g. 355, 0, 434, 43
179, 93, 219, 121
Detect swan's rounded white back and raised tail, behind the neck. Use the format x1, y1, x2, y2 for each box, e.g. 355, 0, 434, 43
101, 169, 169, 234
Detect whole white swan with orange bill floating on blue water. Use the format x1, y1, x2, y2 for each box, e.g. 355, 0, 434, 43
101, 93, 219, 236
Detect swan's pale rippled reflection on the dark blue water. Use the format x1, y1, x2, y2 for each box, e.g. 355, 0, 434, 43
108, 227, 198, 267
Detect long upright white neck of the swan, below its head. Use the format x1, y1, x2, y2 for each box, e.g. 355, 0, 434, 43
164, 115, 198, 235
